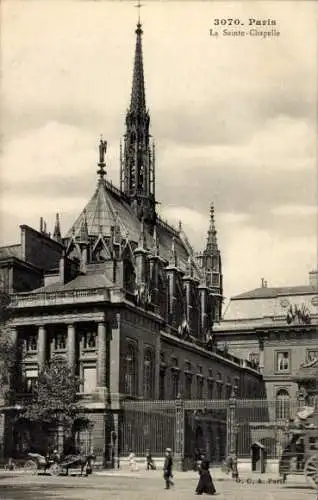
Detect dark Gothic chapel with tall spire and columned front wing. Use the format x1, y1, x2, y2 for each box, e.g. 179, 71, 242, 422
0, 19, 262, 460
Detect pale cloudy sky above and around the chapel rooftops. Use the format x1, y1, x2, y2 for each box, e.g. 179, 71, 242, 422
0, 0, 318, 298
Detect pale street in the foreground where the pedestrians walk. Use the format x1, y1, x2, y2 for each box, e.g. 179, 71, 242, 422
0, 471, 317, 500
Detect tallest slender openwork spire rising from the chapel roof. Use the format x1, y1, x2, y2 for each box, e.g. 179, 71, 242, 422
120, 16, 156, 225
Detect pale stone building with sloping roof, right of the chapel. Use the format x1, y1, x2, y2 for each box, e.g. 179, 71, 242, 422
214, 271, 318, 420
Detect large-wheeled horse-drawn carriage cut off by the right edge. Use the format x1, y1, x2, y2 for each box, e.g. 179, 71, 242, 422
279, 409, 318, 488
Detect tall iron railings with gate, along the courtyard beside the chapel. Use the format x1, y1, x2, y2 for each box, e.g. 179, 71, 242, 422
120, 398, 299, 462
